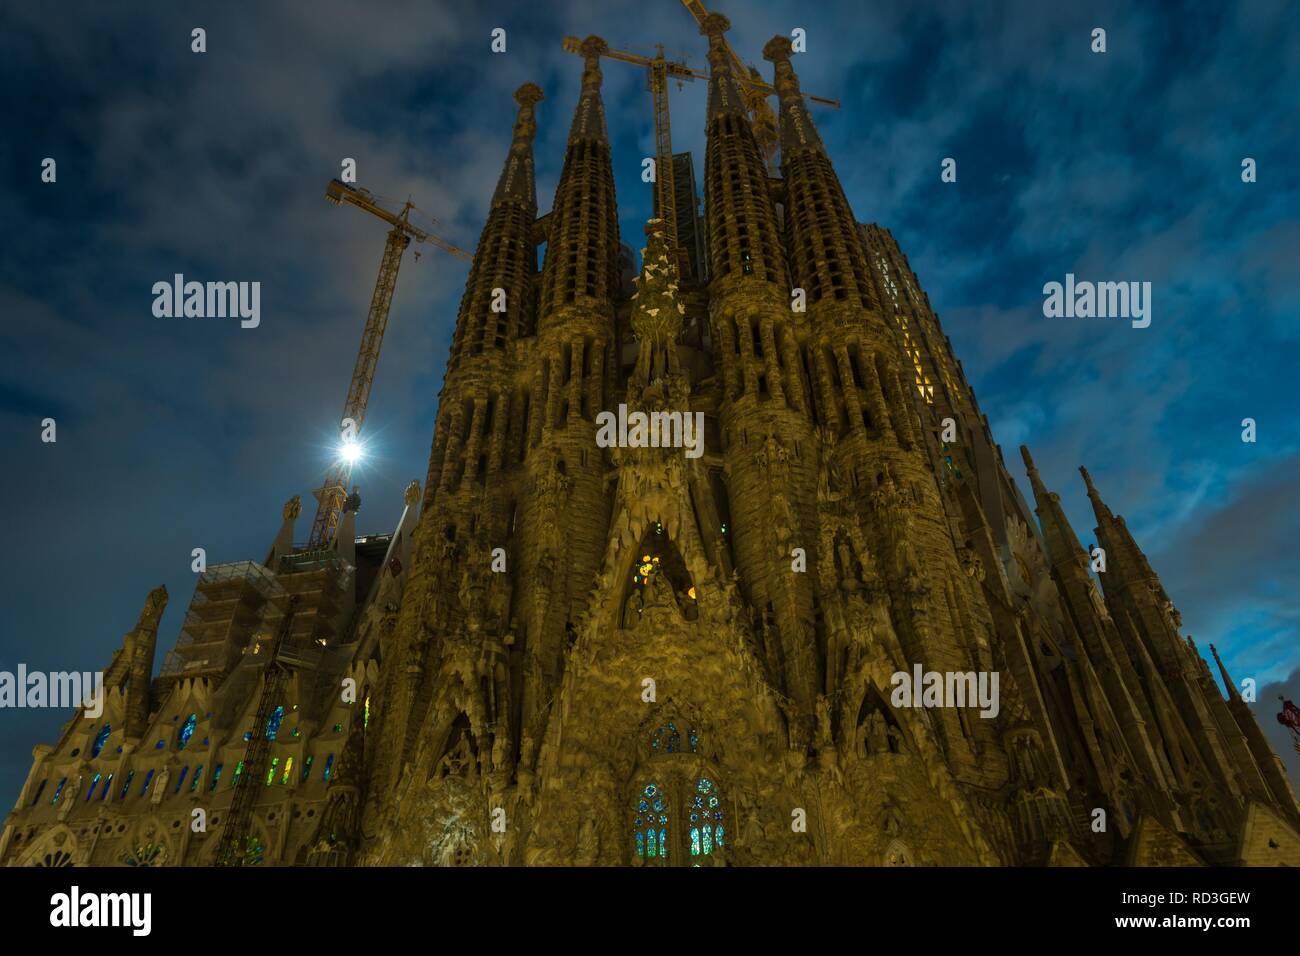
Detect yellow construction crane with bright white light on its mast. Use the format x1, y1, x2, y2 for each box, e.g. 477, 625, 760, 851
307, 179, 473, 549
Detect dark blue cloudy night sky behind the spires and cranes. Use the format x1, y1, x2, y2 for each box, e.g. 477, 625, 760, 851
0, 0, 1300, 806
